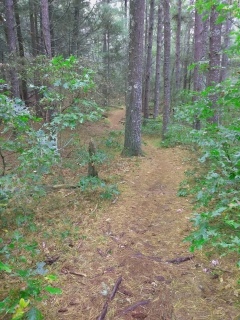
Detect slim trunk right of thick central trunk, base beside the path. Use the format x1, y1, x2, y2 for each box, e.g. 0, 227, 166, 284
162, 0, 171, 139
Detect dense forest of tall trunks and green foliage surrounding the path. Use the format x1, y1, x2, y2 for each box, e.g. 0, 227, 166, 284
0, 0, 240, 319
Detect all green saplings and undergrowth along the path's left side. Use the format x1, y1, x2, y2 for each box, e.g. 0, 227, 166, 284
0, 57, 122, 320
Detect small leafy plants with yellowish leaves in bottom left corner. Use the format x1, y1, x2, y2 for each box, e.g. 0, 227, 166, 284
0, 231, 61, 320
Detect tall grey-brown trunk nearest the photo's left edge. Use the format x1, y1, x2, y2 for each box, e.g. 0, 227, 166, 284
5, 0, 20, 98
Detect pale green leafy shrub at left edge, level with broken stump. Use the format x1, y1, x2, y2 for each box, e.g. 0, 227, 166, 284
0, 95, 59, 208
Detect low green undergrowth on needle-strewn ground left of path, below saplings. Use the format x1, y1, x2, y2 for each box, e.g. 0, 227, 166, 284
0, 122, 123, 319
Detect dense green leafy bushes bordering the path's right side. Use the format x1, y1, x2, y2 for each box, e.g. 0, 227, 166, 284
167, 78, 240, 264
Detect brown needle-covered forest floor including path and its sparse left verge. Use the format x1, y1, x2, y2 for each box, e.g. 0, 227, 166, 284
1, 109, 240, 320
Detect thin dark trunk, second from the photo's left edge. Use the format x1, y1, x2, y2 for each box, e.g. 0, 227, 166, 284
13, 0, 28, 105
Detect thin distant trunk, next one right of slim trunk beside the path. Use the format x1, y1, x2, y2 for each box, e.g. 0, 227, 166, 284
175, 0, 182, 92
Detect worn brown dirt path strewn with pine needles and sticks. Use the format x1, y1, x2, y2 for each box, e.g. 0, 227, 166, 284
49, 110, 240, 320
